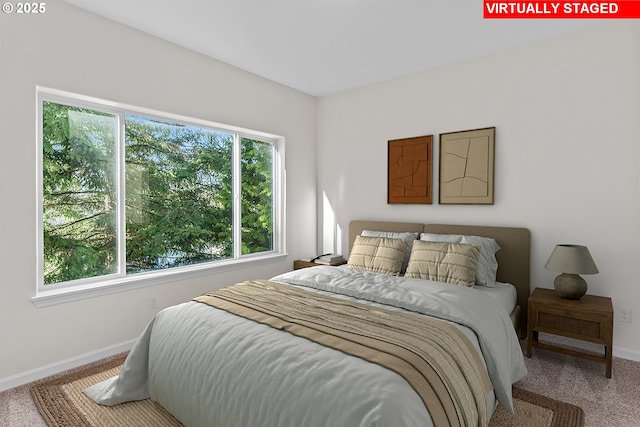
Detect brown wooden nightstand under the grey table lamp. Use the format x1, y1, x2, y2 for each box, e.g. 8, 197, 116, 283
527, 288, 613, 378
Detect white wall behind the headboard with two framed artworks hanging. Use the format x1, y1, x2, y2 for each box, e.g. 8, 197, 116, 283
318, 21, 640, 360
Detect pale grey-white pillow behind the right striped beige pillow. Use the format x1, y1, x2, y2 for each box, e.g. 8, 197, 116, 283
420, 233, 500, 288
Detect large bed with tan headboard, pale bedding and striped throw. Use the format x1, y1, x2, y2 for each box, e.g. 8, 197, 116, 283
85, 221, 530, 427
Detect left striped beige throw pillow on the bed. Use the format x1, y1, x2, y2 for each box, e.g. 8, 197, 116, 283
347, 236, 407, 276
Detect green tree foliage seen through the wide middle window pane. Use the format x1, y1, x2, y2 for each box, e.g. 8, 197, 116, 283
125, 116, 233, 272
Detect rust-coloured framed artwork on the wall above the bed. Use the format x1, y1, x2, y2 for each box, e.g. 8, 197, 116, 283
387, 135, 433, 204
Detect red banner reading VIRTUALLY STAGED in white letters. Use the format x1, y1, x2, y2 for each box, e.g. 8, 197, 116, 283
483, 0, 640, 19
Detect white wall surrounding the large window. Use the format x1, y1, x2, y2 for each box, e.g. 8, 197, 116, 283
0, 0, 317, 388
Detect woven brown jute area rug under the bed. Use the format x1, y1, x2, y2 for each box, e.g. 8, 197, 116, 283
31, 356, 584, 427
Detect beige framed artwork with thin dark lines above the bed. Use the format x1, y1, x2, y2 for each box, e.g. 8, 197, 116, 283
438, 127, 496, 205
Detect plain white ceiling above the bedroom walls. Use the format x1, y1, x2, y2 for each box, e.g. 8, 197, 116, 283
64, 0, 602, 96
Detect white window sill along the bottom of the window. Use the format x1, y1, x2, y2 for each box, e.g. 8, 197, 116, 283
31, 254, 287, 307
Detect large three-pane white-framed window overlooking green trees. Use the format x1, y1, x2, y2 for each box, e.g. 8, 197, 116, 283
38, 91, 283, 300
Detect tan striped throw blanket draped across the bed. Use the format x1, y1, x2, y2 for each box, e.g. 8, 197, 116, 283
194, 280, 492, 426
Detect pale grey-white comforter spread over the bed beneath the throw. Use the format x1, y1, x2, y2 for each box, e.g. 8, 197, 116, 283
85, 267, 526, 427
